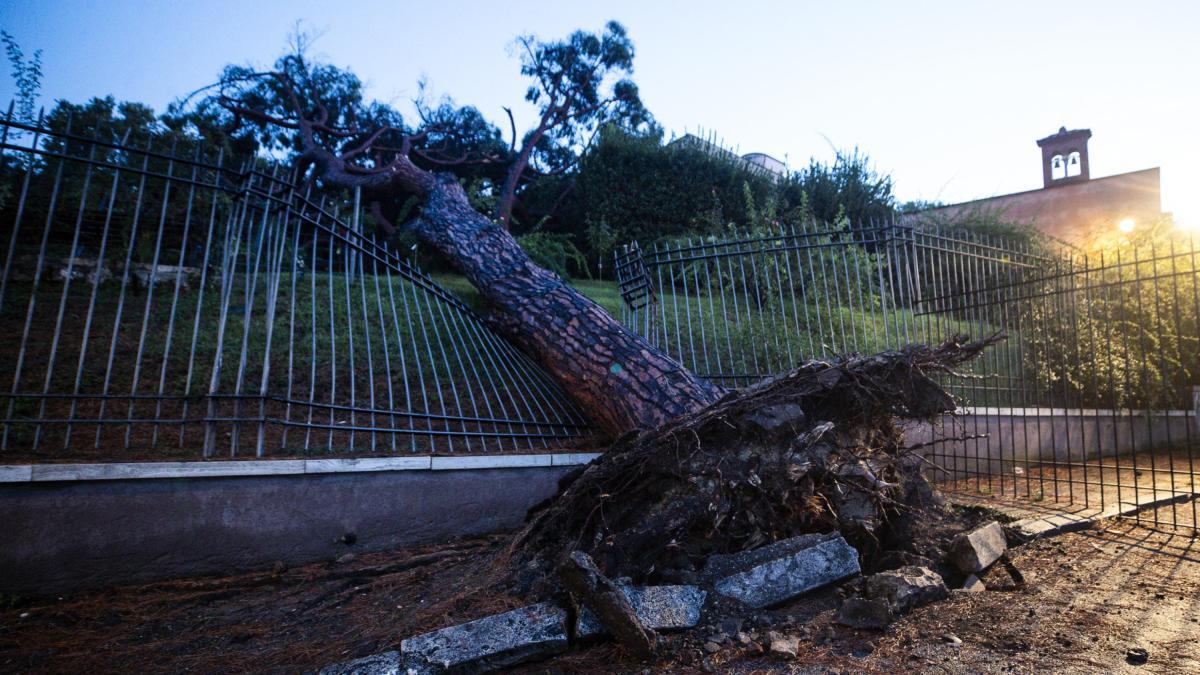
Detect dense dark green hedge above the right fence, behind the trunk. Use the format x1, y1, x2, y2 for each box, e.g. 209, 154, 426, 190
544, 126, 895, 271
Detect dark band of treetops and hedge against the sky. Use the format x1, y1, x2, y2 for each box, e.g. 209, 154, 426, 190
5, 22, 896, 274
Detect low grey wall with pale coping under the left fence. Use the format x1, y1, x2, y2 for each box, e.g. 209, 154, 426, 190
0, 455, 595, 593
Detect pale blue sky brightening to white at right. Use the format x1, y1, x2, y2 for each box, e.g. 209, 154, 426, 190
0, 0, 1200, 226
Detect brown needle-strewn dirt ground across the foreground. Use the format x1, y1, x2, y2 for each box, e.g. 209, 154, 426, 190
0, 509, 1200, 673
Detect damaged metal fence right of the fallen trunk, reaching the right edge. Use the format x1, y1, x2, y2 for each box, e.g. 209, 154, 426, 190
616, 225, 1200, 527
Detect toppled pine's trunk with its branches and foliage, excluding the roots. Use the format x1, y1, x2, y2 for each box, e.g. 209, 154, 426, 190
200, 23, 725, 437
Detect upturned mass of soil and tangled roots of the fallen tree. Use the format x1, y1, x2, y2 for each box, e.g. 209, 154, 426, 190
510, 335, 1003, 593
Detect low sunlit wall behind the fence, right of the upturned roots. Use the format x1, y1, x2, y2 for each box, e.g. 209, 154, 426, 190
905, 408, 1200, 476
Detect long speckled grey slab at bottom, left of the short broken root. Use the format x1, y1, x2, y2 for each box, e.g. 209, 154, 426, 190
400, 603, 566, 673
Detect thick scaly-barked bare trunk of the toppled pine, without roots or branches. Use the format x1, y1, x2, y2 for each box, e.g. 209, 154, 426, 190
414, 175, 725, 436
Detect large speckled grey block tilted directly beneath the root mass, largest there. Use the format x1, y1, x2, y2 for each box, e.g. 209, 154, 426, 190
703, 532, 859, 609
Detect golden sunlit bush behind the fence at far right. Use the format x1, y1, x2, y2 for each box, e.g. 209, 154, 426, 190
1019, 221, 1200, 410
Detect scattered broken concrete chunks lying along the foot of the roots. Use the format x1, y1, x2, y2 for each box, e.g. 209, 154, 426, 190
320, 514, 1032, 675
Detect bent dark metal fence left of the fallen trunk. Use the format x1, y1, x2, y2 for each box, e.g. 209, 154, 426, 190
0, 115, 587, 460
